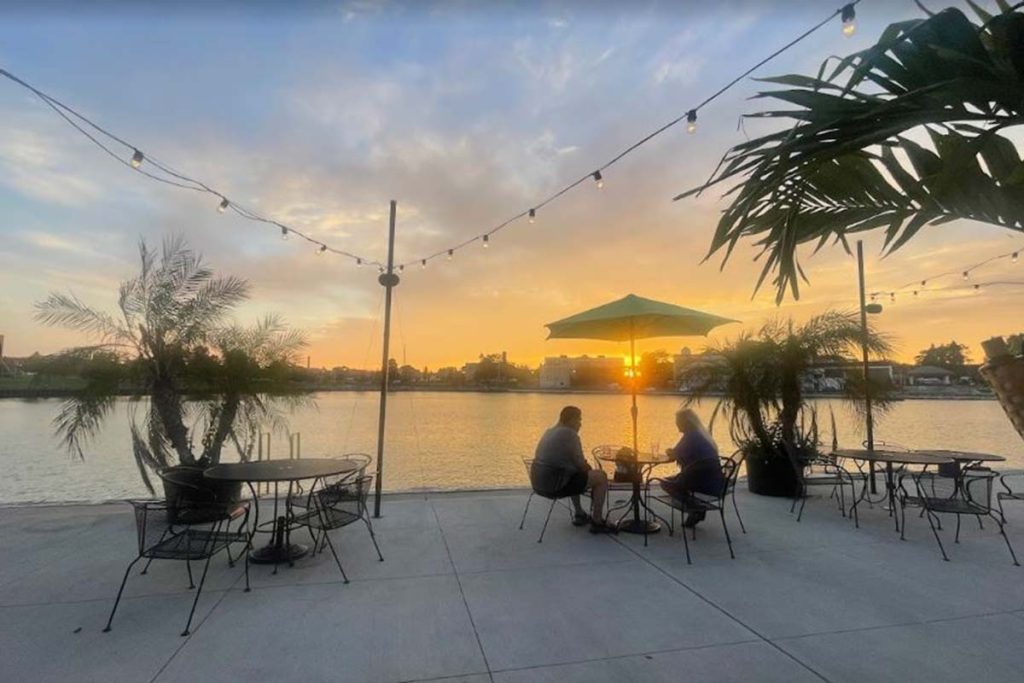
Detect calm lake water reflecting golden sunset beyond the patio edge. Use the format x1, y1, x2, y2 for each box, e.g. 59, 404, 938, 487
0, 392, 1024, 504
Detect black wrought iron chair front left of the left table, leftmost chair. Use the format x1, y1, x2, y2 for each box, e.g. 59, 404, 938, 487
103, 501, 252, 636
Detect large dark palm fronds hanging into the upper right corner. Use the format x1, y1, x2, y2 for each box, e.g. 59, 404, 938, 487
676, 0, 1024, 301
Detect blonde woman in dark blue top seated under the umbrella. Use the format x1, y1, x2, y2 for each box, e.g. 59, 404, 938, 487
662, 408, 725, 526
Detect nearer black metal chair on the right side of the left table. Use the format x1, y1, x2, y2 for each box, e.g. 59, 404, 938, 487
292, 474, 384, 584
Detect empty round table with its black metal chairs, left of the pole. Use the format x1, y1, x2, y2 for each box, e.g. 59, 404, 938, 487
103, 454, 384, 636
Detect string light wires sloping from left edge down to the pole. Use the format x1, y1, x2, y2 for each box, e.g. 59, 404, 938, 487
0, 69, 380, 265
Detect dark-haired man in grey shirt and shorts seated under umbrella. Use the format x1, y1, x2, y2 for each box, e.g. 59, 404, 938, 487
529, 405, 615, 533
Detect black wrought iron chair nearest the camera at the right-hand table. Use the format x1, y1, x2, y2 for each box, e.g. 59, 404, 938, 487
898, 469, 1020, 566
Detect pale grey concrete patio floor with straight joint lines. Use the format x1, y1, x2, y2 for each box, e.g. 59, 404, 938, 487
0, 485, 1024, 683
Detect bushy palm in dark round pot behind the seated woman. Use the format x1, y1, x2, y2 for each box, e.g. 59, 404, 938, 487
683, 311, 891, 496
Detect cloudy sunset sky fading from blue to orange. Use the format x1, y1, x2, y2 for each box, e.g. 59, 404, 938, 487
0, 0, 1024, 369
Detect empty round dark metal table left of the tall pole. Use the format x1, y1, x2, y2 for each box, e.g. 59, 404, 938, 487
203, 458, 359, 571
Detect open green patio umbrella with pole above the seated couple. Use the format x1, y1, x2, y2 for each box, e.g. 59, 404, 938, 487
545, 294, 738, 453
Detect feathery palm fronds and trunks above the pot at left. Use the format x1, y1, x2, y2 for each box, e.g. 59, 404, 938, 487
36, 238, 305, 492
